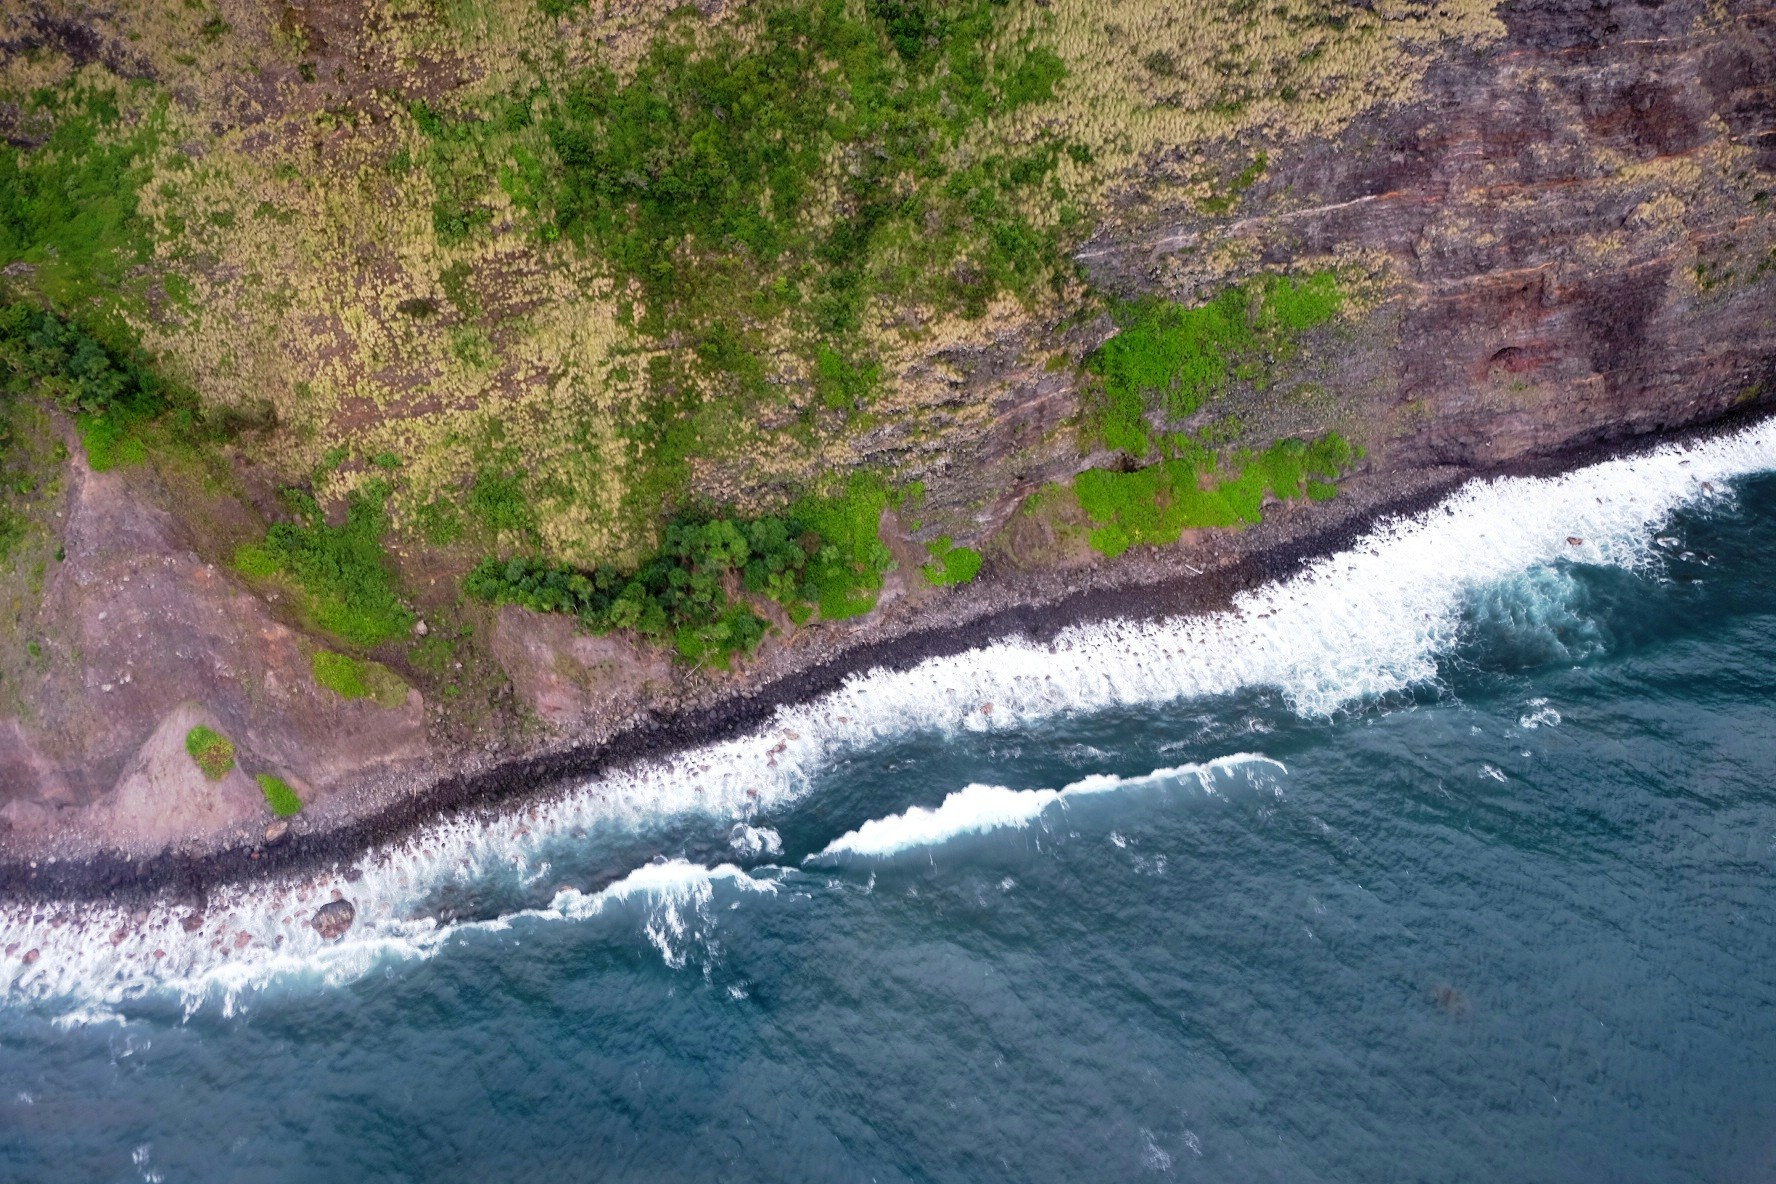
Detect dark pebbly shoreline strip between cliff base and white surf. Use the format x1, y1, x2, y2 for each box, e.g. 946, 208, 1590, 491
0, 407, 1772, 904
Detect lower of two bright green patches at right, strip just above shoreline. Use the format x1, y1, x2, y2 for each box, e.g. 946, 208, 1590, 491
1073, 433, 1353, 557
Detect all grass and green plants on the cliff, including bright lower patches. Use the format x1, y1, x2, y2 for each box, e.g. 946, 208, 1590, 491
0, 0, 1497, 657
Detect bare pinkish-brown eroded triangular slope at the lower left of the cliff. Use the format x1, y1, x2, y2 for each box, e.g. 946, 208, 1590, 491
0, 451, 430, 856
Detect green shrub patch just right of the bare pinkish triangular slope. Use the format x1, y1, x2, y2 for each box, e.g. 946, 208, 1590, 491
234, 481, 414, 646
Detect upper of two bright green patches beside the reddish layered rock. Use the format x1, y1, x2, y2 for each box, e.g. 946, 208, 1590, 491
1087, 272, 1343, 458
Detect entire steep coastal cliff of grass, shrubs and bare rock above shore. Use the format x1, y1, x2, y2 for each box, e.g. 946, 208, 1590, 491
0, 0, 1776, 876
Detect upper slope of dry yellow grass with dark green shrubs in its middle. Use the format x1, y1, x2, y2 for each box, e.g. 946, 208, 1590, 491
0, 0, 1490, 550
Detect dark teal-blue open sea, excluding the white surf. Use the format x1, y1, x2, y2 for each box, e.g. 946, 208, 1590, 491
0, 478, 1776, 1182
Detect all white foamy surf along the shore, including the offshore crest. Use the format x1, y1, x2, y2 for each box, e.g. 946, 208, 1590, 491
0, 421, 1776, 1024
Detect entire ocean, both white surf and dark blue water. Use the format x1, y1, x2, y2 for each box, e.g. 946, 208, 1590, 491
0, 424, 1776, 1182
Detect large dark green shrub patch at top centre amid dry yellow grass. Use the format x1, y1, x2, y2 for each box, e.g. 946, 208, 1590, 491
549, 0, 1066, 337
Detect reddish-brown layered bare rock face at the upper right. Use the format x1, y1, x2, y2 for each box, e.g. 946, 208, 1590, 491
1082, 0, 1776, 467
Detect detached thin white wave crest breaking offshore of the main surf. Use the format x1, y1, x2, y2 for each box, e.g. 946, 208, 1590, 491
808, 753, 1288, 861
